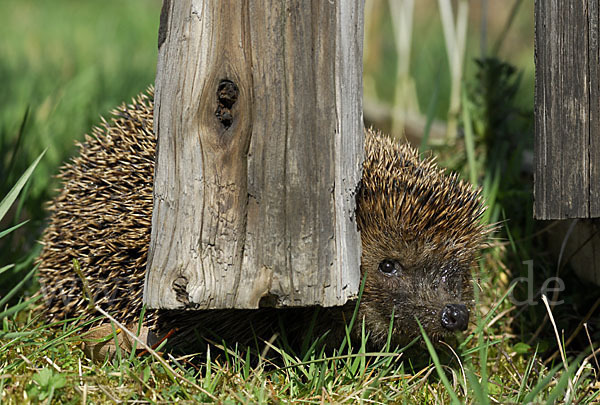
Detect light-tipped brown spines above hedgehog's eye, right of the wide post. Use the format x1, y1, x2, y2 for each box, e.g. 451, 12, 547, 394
357, 131, 488, 260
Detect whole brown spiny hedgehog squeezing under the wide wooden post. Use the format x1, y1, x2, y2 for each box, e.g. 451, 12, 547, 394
38, 87, 490, 347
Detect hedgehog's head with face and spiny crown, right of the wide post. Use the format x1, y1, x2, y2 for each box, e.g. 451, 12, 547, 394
357, 131, 487, 344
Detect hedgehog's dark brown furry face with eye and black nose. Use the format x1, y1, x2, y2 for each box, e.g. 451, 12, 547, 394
359, 237, 472, 345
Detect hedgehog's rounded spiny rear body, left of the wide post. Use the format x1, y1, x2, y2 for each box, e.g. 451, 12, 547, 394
39, 88, 155, 322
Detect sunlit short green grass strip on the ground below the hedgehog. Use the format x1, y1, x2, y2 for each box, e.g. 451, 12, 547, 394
0, 266, 598, 404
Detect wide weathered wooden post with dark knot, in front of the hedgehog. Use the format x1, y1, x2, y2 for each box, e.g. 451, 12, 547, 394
144, 0, 364, 309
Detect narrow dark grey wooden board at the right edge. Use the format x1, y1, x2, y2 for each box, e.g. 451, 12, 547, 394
534, 0, 600, 219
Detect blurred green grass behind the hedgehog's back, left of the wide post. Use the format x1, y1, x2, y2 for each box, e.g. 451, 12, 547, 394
0, 0, 160, 278
